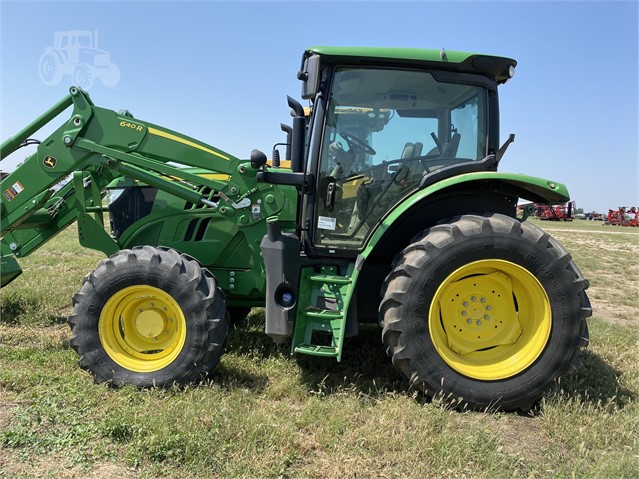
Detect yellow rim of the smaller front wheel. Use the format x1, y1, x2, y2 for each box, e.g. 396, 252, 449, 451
98, 285, 186, 373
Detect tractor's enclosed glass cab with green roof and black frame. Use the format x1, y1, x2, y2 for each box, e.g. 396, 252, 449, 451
261, 47, 516, 256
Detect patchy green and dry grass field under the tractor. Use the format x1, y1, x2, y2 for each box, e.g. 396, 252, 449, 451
0, 221, 639, 479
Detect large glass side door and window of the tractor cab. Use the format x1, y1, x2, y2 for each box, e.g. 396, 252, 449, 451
314, 68, 487, 248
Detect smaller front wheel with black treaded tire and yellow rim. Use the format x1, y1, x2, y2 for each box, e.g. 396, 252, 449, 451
68, 246, 229, 388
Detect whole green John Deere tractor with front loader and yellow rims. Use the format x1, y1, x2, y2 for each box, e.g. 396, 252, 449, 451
0, 47, 591, 410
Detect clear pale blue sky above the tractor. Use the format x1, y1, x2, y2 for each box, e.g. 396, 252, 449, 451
0, 1, 639, 212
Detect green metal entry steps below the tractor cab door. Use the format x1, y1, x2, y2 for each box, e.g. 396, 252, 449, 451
292, 264, 357, 362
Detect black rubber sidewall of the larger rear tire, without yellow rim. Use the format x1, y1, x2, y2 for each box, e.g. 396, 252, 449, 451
392, 218, 579, 408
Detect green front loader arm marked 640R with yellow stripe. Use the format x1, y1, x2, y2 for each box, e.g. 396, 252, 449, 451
0, 87, 264, 286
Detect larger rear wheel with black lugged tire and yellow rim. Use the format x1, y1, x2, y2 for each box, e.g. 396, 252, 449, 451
380, 214, 592, 411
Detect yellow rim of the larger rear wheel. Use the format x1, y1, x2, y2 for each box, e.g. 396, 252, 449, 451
428, 260, 552, 381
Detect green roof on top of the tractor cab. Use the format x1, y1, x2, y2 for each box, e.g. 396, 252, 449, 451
306, 46, 517, 83
